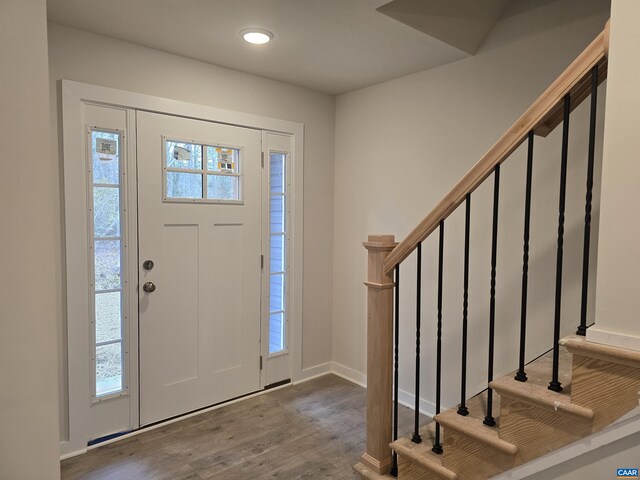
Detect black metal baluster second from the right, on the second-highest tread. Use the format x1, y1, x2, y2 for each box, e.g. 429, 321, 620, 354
548, 93, 571, 392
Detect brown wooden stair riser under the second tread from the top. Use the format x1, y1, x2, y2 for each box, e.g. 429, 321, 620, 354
499, 396, 592, 465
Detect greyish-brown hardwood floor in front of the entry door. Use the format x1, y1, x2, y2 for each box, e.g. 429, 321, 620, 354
61, 375, 413, 480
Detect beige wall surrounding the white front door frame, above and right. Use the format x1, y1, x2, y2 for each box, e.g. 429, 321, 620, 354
49, 23, 335, 438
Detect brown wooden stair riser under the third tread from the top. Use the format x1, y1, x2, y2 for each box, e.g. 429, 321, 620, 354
442, 427, 516, 480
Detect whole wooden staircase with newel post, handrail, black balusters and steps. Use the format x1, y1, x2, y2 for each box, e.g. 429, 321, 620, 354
354, 19, 640, 480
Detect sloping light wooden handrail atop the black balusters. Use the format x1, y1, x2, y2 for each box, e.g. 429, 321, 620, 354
383, 23, 609, 274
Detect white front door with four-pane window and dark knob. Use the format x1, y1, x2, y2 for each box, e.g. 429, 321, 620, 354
137, 112, 262, 425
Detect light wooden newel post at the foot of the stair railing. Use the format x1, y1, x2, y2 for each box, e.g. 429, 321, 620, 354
362, 235, 397, 474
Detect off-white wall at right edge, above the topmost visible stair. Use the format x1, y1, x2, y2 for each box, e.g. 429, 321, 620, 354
588, 0, 640, 350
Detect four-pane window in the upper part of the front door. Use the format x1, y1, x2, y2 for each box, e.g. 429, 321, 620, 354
163, 137, 243, 203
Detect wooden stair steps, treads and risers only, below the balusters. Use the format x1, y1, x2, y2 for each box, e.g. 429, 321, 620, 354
354, 337, 640, 480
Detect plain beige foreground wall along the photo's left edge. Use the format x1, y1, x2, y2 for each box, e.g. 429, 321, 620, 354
0, 0, 60, 480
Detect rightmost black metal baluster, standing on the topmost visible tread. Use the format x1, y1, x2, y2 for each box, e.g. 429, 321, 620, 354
576, 65, 598, 336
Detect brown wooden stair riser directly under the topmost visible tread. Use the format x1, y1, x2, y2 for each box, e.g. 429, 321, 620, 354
571, 354, 640, 432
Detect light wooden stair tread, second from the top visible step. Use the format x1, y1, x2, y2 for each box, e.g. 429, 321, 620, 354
489, 376, 594, 420
